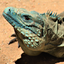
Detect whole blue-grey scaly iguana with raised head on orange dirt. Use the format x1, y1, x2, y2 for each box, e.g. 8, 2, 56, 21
3, 7, 64, 57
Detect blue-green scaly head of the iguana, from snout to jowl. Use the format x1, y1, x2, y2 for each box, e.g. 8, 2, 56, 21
3, 7, 44, 48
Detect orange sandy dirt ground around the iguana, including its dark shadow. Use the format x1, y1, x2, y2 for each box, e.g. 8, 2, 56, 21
0, 0, 64, 64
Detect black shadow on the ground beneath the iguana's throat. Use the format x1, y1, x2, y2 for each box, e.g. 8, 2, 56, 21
15, 53, 64, 64
